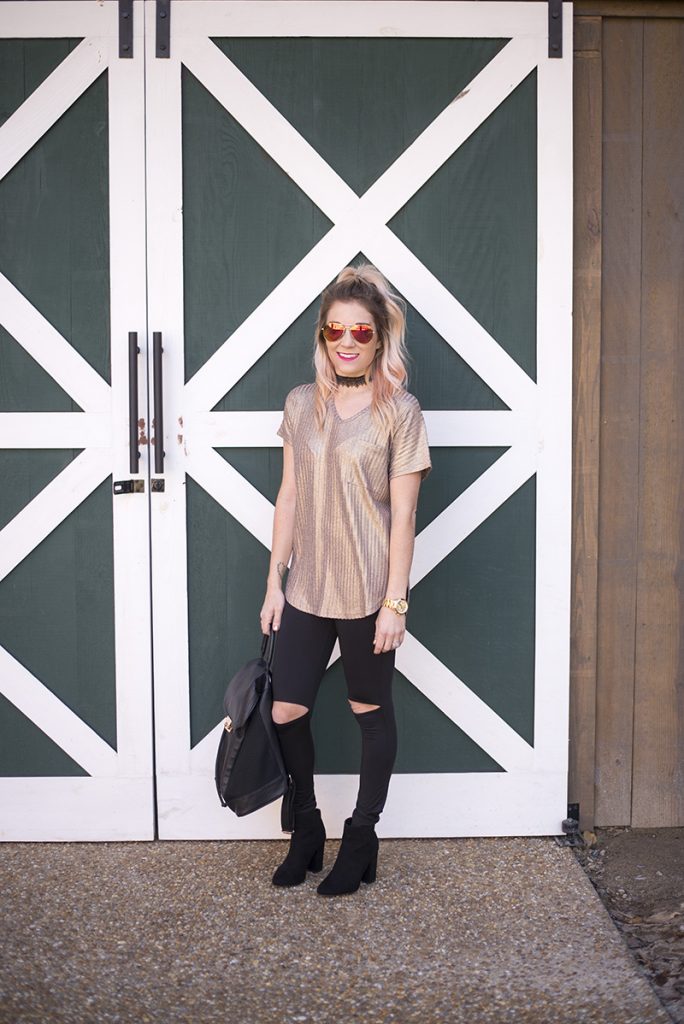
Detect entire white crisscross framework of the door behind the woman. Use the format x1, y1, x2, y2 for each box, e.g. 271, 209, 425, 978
146, 0, 571, 839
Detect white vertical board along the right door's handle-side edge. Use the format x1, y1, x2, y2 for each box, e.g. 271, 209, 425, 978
145, 4, 191, 790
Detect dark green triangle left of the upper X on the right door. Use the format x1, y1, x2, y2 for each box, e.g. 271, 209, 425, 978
182, 68, 331, 387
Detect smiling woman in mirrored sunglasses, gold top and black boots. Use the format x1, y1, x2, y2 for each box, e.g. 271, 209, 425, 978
261, 265, 431, 896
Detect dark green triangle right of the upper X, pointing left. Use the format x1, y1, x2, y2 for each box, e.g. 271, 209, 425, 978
389, 71, 537, 379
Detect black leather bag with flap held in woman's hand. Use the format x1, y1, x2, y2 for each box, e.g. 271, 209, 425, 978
215, 630, 295, 833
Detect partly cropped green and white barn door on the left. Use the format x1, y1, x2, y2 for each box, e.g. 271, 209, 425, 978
0, 2, 154, 840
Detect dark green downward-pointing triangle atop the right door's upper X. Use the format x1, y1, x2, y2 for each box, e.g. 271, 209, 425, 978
213, 38, 508, 196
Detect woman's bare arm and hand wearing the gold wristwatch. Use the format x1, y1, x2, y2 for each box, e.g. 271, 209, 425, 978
374, 472, 422, 654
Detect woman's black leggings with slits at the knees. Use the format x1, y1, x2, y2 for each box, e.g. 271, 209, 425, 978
273, 601, 396, 825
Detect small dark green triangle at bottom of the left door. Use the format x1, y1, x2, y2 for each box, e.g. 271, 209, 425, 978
0, 694, 88, 777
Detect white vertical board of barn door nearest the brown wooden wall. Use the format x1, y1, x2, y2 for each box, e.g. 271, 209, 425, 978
535, 4, 572, 771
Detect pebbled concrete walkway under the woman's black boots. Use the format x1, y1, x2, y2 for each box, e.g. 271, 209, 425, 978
0, 838, 671, 1024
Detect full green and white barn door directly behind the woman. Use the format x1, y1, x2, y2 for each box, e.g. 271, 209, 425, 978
145, 0, 572, 838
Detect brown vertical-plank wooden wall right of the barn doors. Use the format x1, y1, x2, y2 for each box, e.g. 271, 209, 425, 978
568, 0, 684, 829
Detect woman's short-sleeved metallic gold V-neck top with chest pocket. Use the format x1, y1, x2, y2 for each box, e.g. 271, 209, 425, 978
277, 384, 432, 618
